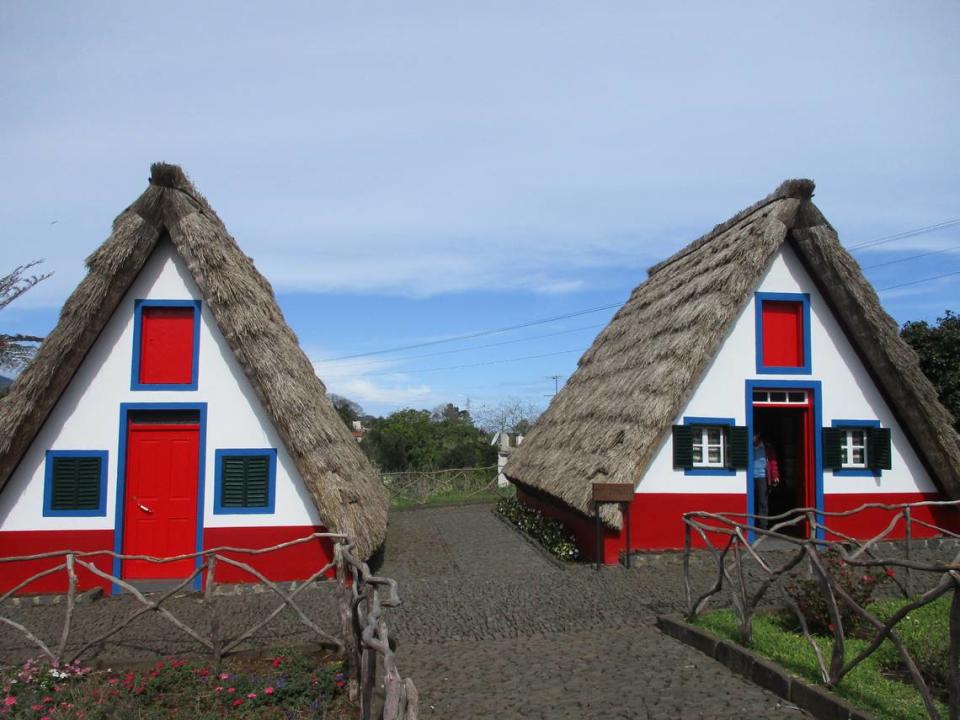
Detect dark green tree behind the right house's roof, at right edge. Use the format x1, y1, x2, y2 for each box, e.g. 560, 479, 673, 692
900, 310, 960, 432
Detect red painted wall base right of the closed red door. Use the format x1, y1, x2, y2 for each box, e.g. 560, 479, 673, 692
203, 525, 336, 583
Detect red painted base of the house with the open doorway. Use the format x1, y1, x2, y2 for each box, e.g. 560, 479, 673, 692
517, 487, 960, 564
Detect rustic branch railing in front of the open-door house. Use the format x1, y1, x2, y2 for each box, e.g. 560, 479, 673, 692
683, 501, 960, 720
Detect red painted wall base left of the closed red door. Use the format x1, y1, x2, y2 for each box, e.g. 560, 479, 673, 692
0, 530, 113, 595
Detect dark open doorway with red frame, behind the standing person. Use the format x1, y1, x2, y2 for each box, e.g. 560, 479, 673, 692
753, 389, 816, 535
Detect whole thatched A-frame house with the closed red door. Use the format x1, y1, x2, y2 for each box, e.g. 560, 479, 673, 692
0, 164, 387, 592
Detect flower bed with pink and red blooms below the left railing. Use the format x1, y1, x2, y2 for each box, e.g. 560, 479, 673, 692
0, 652, 356, 720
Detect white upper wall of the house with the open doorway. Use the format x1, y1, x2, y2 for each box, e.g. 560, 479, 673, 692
637, 246, 936, 495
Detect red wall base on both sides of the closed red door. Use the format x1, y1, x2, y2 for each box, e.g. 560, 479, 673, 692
0, 525, 335, 595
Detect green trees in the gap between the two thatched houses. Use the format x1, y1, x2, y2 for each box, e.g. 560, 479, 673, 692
361, 405, 497, 472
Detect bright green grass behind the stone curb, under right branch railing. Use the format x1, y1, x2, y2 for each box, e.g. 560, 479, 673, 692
694, 601, 946, 720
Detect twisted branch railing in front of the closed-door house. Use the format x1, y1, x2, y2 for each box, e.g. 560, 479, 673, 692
0, 533, 417, 720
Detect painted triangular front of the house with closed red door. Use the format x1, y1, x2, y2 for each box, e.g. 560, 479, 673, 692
0, 242, 330, 592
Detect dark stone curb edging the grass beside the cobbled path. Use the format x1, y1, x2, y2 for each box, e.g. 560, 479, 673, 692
657, 615, 875, 720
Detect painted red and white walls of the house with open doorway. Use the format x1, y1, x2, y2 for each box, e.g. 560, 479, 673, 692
519, 245, 954, 562
